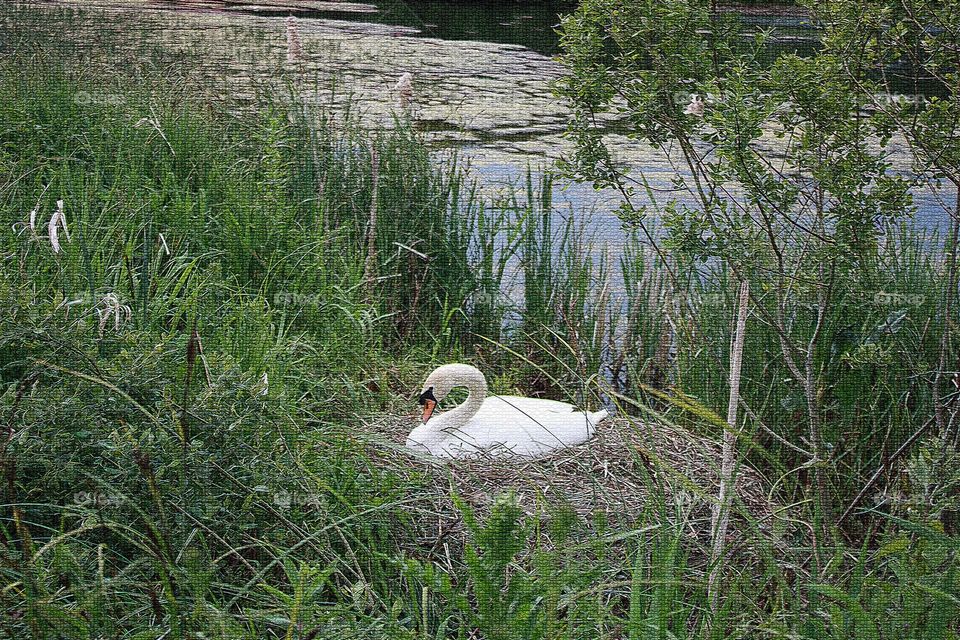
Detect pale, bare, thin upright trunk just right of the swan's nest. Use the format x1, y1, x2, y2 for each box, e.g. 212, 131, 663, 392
707, 280, 750, 613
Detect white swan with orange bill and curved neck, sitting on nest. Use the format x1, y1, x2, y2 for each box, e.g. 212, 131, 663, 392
407, 363, 607, 458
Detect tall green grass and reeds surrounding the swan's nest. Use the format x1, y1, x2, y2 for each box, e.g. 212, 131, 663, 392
0, 15, 960, 640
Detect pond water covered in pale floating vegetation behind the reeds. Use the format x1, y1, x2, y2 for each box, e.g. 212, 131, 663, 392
0, 0, 950, 251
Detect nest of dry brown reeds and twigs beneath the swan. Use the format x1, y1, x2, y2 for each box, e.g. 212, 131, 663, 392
356, 417, 780, 556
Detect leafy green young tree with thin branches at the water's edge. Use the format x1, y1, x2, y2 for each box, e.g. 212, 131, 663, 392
558, 0, 956, 556
